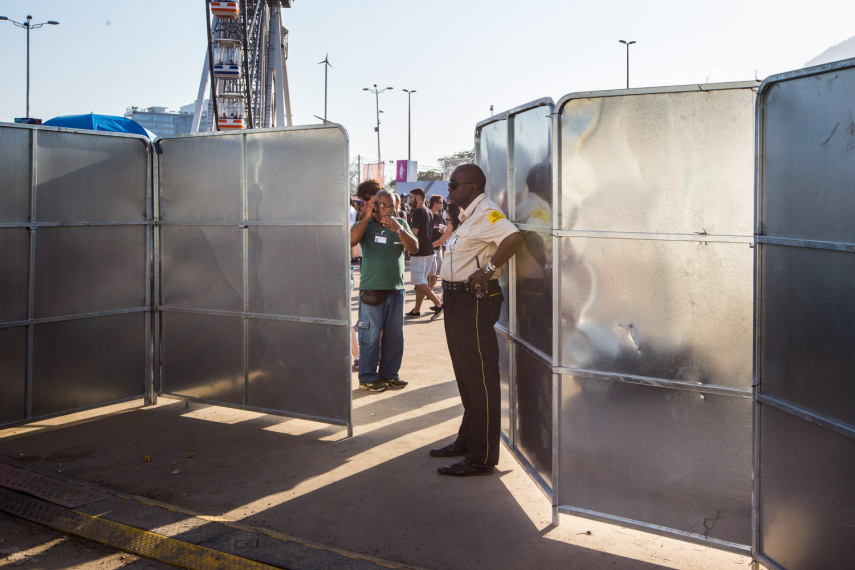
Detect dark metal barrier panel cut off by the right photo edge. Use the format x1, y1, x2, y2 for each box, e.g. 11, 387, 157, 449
754, 59, 855, 569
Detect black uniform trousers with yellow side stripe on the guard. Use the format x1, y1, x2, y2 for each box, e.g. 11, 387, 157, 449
443, 291, 504, 465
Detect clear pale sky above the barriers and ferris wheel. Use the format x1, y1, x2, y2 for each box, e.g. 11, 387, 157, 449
0, 0, 855, 173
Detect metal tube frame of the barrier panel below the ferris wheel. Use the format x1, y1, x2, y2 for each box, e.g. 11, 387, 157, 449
155, 124, 353, 435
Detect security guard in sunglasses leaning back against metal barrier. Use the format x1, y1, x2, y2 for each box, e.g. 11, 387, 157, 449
430, 164, 523, 477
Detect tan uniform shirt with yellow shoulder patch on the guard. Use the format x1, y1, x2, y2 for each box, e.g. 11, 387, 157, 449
439, 194, 519, 281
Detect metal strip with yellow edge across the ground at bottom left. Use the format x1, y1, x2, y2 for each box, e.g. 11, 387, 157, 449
0, 463, 422, 570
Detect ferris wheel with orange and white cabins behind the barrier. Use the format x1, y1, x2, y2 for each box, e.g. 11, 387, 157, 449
193, 0, 291, 132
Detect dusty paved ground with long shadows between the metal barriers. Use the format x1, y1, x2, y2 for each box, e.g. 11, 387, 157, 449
0, 268, 751, 570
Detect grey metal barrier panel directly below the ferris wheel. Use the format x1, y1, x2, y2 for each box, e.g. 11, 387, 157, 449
157, 126, 351, 426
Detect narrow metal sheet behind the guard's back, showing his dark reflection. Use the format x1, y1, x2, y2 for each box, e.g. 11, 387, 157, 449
508, 99, 554, 493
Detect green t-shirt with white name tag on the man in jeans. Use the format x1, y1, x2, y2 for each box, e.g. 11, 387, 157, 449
354, 218, 410, 291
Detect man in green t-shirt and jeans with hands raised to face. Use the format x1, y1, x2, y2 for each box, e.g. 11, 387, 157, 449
350, 180, 419, 392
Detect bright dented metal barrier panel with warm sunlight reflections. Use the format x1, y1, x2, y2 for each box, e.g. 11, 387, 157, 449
553, 83, 755, 550
